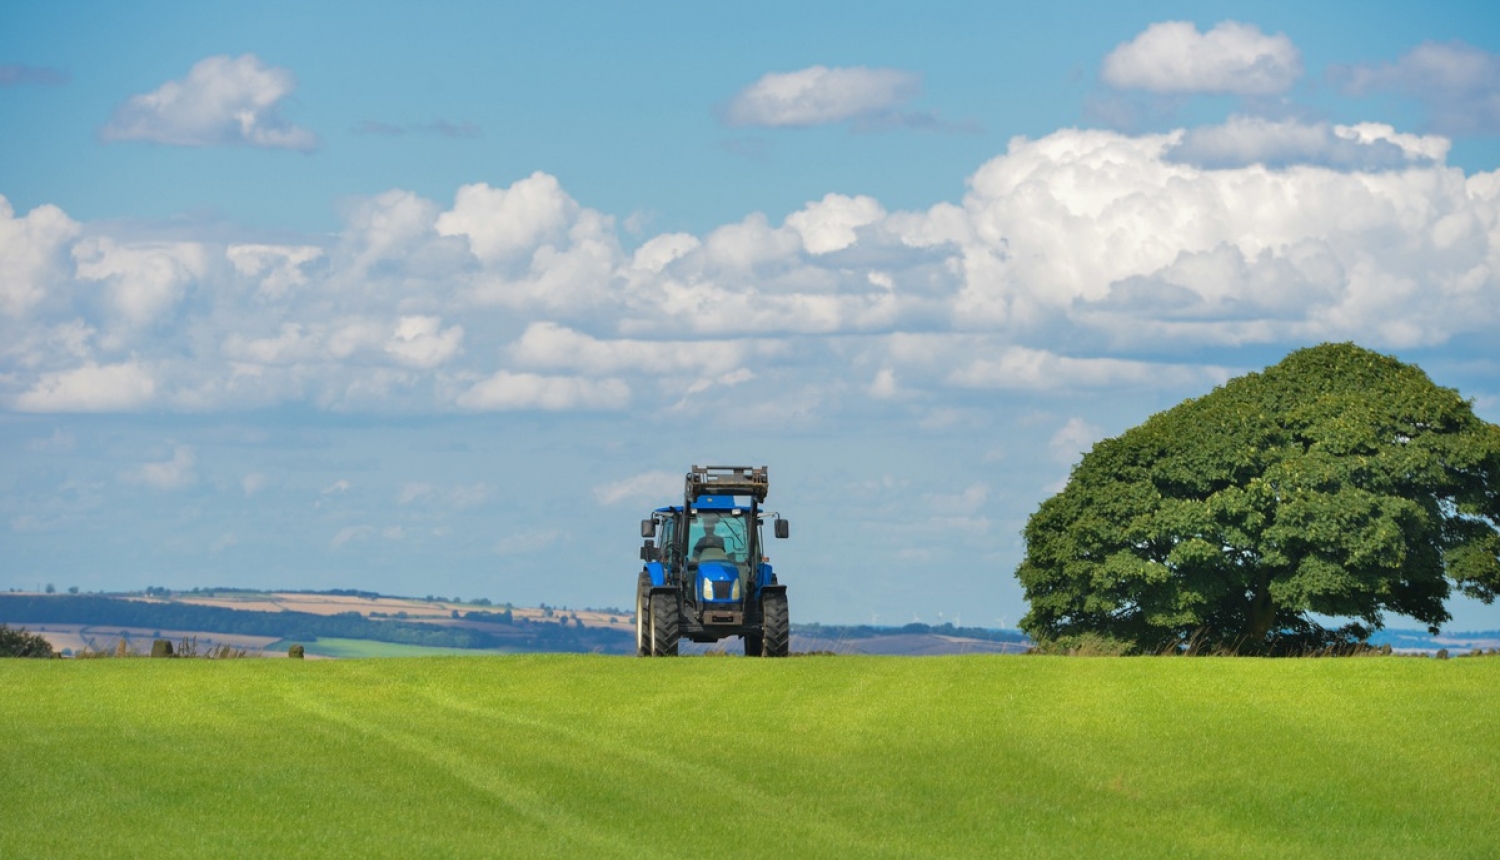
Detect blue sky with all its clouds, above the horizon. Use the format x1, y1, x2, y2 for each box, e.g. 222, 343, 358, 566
0, 3, 1500, 627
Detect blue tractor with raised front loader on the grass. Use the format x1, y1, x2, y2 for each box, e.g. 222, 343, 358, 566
636, 465, 791, 657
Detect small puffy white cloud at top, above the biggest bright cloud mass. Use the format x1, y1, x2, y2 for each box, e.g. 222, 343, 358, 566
1101, 21, 1302, 96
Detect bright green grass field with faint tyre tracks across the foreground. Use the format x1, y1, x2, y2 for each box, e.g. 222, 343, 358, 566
0, 654, 1500, 860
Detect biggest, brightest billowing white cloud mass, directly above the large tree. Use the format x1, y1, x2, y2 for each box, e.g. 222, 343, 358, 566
954, 124, 1500, 347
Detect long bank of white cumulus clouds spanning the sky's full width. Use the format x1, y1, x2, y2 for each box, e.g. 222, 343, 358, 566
0, 117, 1500, 417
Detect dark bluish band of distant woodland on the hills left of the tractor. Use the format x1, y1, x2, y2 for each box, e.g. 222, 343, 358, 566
0, 594, 635, 653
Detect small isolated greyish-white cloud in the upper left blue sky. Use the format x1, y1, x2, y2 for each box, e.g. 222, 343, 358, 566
101, 54, 318, 152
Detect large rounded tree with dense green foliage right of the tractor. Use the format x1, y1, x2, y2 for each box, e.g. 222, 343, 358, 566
1017, 344, 1500, 653
